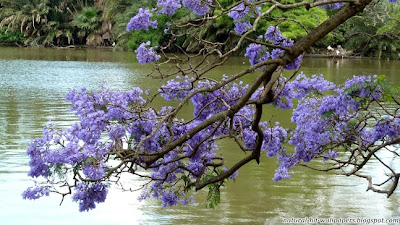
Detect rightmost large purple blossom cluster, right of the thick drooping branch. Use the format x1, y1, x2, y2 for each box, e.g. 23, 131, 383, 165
274, 75, 390, 181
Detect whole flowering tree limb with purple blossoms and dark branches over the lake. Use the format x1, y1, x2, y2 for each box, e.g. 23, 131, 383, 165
23, 0, 400, 211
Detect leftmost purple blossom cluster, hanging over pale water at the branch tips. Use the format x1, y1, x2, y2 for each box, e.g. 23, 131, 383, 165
23, 85, 152, 211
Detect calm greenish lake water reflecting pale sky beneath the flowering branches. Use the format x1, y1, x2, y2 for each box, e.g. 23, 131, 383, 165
0, 47, 400, 225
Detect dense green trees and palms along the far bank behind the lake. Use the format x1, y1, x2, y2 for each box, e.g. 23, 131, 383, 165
0, 0, 400, 58
